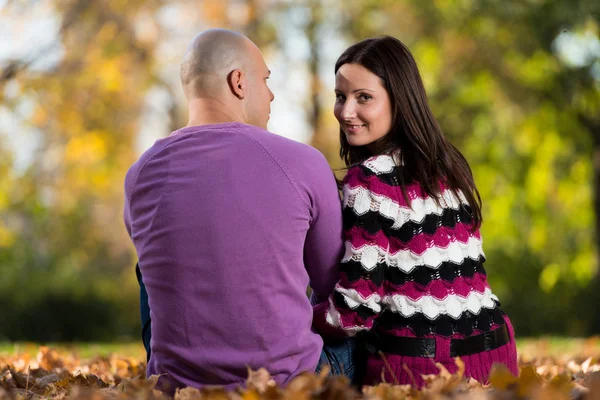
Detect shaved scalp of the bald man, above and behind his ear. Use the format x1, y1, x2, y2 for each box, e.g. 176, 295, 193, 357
181, 29, 256, 97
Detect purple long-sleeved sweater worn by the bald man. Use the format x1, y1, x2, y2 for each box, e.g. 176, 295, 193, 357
124, 123, 343, 388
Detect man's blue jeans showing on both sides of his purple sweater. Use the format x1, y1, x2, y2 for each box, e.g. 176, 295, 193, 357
135, 263, 357, 384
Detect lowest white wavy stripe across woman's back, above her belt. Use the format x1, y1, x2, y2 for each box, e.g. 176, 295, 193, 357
382, 288, 498, 319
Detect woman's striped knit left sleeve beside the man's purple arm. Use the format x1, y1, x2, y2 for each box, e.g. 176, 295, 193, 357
313, 167, 386, 336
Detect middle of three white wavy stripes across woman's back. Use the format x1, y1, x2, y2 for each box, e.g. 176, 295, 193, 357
342, 236, 485, 273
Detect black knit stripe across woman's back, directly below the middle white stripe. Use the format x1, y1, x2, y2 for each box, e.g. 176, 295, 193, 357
342, 256, 486, 287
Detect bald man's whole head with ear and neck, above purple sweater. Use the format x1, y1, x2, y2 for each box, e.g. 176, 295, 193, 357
181, 29, 274, 128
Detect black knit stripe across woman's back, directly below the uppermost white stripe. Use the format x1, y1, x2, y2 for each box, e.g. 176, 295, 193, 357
343, 205, 473, 243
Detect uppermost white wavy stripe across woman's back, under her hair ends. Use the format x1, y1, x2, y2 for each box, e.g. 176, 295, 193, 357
343, 184, 468, 229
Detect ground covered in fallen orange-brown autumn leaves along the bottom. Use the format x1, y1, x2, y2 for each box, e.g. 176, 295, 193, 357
0, 339, 600, 400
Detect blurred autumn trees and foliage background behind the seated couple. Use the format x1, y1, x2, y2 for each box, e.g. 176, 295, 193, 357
0, 0, 600, 342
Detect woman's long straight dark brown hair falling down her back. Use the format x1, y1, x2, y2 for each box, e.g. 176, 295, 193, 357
335, 36, 483, 229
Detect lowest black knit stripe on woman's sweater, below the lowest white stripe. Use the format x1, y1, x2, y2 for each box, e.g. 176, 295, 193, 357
376, 306, 504, 337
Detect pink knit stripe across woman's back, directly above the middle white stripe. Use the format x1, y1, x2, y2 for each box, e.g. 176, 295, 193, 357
344, 222, 481, 255
